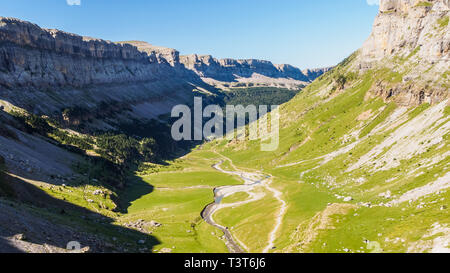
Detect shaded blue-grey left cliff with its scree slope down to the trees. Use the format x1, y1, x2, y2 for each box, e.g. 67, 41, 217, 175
0, 18, 206, 123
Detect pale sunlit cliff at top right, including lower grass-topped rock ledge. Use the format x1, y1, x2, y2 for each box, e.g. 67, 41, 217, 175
356, 0, 450, 105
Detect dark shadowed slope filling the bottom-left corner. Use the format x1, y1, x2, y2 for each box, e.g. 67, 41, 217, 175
0, 174, 160, 253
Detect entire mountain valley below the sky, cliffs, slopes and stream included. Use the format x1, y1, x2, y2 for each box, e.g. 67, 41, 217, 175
0, 0, 450, 253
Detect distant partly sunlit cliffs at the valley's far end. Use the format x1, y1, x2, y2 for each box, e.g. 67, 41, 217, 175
127, 41, 331, 88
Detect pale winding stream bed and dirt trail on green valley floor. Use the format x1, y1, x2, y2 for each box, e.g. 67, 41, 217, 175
202, 155, 287, 253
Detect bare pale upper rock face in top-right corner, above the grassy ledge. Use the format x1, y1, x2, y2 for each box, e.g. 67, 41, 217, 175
361, 0, 450, 63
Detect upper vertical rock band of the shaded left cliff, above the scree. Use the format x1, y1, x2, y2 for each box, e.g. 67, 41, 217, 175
0, 18, 167, 87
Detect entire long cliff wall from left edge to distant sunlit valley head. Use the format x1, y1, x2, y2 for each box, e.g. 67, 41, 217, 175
0, 17, 326, 123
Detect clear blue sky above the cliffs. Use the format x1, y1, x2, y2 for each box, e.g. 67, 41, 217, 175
0, 0, 378, 68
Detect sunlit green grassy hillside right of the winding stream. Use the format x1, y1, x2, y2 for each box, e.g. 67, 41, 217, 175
135, 50, 450, 252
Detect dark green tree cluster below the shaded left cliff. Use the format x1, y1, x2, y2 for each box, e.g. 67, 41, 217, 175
10, 108, 177, 166
